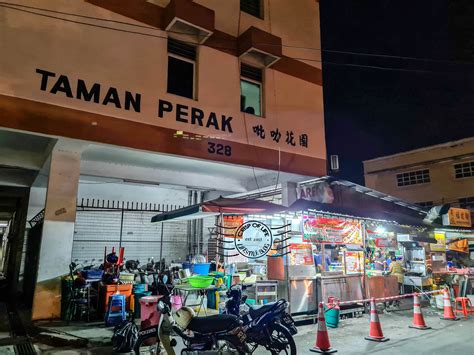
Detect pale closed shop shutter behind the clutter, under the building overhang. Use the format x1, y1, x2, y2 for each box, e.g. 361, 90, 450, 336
72, 209, 215, 264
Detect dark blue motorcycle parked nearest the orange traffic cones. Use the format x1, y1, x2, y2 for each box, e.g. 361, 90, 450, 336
225, 284, 298, 355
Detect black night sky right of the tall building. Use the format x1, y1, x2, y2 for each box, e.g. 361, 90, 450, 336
320, 0, 474, 183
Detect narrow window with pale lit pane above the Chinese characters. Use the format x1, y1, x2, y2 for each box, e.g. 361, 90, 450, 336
240, 64, 262, 116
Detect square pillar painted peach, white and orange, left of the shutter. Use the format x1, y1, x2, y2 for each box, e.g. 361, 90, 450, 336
32, 142, 81, 320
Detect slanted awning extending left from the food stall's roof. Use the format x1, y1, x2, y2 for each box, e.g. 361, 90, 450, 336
151, 197, 285, 222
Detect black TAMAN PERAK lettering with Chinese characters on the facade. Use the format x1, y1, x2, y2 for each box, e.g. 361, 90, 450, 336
36, 68, 311, 155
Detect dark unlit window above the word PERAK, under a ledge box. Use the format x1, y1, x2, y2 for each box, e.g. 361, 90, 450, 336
168, 38, 196, 99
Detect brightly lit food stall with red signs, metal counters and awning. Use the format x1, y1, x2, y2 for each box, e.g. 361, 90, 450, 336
148, 198, 436, 318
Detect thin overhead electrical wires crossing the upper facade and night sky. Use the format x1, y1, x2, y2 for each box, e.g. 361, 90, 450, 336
0, 1, 474, 64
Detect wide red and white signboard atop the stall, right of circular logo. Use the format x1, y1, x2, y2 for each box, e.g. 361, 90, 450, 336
303, 216, 363, 245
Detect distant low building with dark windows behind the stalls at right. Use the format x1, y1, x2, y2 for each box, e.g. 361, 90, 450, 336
364, 138, 474, 210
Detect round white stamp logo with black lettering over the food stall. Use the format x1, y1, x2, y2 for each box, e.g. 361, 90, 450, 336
234, 221, 272, 259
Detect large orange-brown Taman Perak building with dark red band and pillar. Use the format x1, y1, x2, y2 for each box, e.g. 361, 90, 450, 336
0, 0, 326, 319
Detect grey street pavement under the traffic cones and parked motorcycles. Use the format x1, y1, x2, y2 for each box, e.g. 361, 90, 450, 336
0, 307, 474, 355
